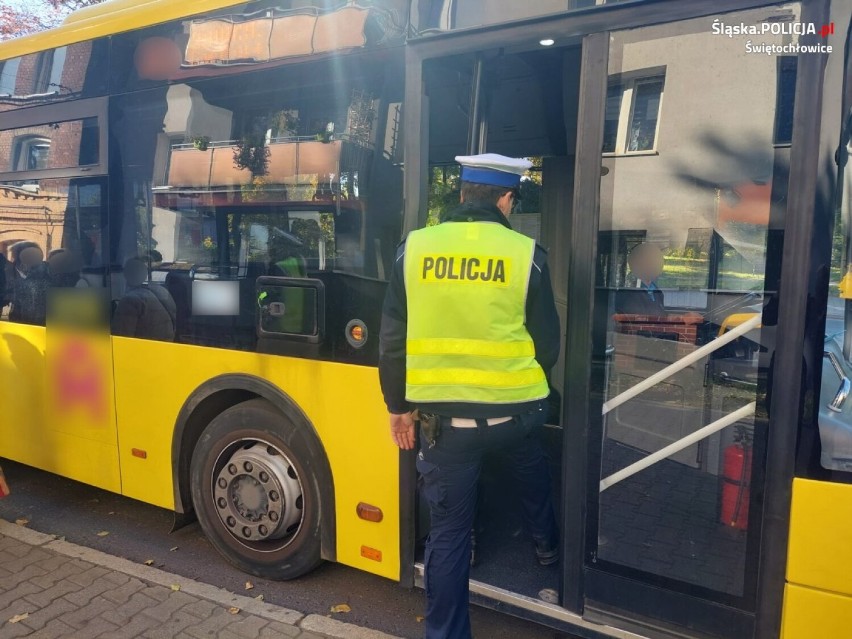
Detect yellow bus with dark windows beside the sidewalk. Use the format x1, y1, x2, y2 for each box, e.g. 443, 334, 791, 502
0, 0, 852, 639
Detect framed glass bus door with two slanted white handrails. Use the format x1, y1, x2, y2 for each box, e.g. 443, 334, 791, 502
562, 3, 820, 638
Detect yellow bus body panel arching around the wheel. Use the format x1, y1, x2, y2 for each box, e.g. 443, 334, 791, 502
112, 337, 400, 579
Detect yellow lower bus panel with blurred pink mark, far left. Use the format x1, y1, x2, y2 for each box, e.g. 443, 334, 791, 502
0, 322, 121, 492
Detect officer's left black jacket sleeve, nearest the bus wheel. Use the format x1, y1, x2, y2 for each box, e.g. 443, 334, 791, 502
379, 244, 413, 414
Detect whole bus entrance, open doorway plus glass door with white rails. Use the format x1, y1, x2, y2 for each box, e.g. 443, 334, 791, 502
406, 2, 824, 637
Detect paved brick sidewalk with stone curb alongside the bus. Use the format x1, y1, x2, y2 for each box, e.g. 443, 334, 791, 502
0, 520, 402, 639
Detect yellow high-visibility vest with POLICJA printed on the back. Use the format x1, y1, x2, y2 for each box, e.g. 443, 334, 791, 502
404, 222, 549, 404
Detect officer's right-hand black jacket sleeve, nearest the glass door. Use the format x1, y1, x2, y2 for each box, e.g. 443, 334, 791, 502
526, 246, 560, 379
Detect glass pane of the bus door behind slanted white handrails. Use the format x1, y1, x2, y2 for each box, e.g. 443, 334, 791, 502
596, 4, 799, 600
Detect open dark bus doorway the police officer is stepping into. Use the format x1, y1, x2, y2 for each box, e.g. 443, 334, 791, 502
406, 28, 581, 621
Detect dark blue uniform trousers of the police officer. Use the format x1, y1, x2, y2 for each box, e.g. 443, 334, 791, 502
417, 411, 558, 639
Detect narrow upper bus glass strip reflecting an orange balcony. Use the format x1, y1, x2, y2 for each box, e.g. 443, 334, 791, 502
111, 0, 408, 92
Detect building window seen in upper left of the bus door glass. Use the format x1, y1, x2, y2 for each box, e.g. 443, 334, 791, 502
603, 75, 665, 154
